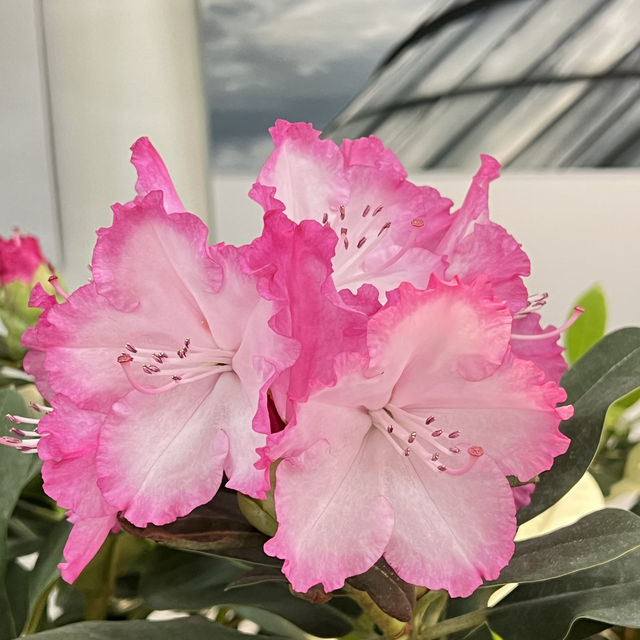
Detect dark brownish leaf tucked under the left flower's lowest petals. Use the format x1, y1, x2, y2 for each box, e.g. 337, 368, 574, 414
121, 490, 282, 567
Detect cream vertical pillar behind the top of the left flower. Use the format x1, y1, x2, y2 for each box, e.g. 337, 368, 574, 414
41, 0, 210, 285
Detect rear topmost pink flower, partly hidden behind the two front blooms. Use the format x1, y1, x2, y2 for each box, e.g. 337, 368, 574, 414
249, 120, 566, 381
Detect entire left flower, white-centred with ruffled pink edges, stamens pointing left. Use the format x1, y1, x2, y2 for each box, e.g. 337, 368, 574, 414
5, 141, 299, 580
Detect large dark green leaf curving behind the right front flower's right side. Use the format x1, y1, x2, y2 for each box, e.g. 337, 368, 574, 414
518, 327, 640, 524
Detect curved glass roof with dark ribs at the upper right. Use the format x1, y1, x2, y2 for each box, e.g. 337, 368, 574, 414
328, 0, 640, 169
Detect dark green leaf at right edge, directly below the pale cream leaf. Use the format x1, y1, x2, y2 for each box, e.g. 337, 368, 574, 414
491, 509, 640, 584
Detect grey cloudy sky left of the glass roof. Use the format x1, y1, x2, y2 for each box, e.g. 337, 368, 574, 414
201, 0, 430, 173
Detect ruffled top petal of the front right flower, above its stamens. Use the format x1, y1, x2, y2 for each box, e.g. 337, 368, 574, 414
368, 278, 511, 392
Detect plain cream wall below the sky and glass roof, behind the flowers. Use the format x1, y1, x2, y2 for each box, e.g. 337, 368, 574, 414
214, 169, 640, 330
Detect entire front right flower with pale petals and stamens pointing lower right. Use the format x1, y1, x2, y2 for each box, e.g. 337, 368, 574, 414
263, 278, 572, 596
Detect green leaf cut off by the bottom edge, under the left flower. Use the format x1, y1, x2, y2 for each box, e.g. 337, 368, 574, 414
10, 616, 274, 640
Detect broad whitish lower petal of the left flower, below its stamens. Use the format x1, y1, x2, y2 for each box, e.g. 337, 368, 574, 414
97, 372, 264, 527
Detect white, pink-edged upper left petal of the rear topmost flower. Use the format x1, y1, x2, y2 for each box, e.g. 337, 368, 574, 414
249, 120, 349, 222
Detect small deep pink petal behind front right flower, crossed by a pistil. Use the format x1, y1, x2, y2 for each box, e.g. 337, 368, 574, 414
511, 313, 567, 382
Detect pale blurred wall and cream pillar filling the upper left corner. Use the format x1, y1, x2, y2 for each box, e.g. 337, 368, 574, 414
0, 0, 211, 285
